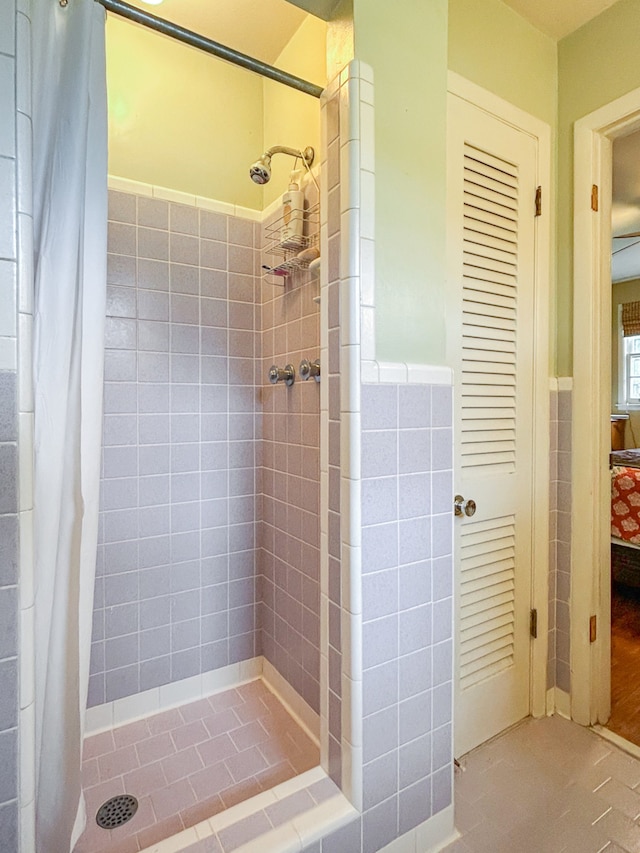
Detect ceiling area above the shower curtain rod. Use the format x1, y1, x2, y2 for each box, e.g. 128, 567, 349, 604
127, 0, 307, 65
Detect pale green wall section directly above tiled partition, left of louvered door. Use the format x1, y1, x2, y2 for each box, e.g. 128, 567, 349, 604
353, 0, 447, 364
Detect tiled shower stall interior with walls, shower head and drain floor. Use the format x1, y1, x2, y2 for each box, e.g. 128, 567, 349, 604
75, 4, 335, 853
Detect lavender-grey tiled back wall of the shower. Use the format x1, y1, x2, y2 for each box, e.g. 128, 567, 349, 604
89, 191, 262, 705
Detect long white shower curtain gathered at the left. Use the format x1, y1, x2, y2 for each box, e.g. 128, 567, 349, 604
32, 0, 107, 853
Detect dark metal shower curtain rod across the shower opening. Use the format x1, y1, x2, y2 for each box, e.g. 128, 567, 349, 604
94, 0, 322, 98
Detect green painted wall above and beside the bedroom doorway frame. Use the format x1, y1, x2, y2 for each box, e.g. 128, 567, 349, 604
557, 0, 640, 376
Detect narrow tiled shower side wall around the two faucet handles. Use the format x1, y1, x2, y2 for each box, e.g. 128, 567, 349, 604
258, 181, 326, 713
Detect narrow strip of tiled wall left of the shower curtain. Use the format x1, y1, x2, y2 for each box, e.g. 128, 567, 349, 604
0, 0, 35, 853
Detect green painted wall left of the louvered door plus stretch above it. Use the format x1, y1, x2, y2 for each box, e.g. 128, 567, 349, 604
354, 0, 557, 364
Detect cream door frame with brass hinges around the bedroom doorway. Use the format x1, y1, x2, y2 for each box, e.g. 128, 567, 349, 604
571, 89, 640, 725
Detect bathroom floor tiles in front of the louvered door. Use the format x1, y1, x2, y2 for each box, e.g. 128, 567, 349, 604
443, 716, 640, 853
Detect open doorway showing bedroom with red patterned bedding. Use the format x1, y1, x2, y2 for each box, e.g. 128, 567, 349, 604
607, 131, 640, 746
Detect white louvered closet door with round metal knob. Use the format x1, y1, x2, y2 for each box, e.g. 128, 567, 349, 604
447, 95, 537, 755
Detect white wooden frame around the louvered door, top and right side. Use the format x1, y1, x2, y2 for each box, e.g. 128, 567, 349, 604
448, 71, 555, 722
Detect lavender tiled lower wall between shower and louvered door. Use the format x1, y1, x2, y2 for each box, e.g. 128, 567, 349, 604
362, 384, 453, 853
